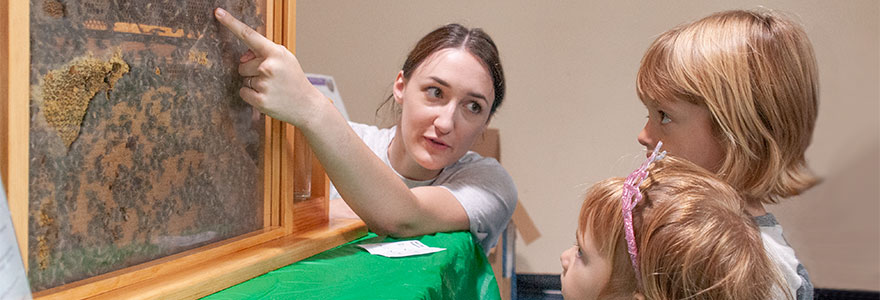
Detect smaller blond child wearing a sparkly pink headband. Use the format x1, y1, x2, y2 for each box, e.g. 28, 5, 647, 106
561, 152, 790, 300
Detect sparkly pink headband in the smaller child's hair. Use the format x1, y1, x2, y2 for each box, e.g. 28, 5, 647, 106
620, 141, 666, 286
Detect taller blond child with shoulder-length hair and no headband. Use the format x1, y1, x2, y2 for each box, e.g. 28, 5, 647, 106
637, 10, 819, 299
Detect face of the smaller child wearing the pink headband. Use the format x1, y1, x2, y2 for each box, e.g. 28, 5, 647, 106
559, 229, 611, 300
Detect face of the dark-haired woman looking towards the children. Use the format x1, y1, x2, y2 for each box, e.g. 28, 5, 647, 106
394, 48, 495, 175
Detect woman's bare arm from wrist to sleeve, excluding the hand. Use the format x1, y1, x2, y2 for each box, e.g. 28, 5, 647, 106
302, 96, 469, 236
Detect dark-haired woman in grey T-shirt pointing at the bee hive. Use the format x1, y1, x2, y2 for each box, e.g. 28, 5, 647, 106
215, 8, 517, 251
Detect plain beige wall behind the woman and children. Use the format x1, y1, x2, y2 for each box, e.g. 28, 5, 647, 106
297, 0, 880, 290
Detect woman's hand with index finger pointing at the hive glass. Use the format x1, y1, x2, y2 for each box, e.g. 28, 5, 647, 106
214, 8, 327, 127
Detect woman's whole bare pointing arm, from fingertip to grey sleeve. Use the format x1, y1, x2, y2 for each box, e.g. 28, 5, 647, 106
215, 9, 469, 237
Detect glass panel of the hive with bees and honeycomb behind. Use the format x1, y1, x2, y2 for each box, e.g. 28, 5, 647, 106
28, 0, 266, 291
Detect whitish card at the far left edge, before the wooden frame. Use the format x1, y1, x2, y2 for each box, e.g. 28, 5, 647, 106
0, 176, 31, 299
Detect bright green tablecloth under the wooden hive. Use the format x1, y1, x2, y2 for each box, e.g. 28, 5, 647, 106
203, 231, 501, 299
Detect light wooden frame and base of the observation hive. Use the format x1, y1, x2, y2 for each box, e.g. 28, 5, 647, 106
0, 0, 366, 299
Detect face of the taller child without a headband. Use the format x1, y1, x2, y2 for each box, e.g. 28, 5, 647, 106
638, 100, 724, 172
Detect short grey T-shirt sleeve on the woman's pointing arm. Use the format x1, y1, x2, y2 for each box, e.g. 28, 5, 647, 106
439, 158, 517, 253
